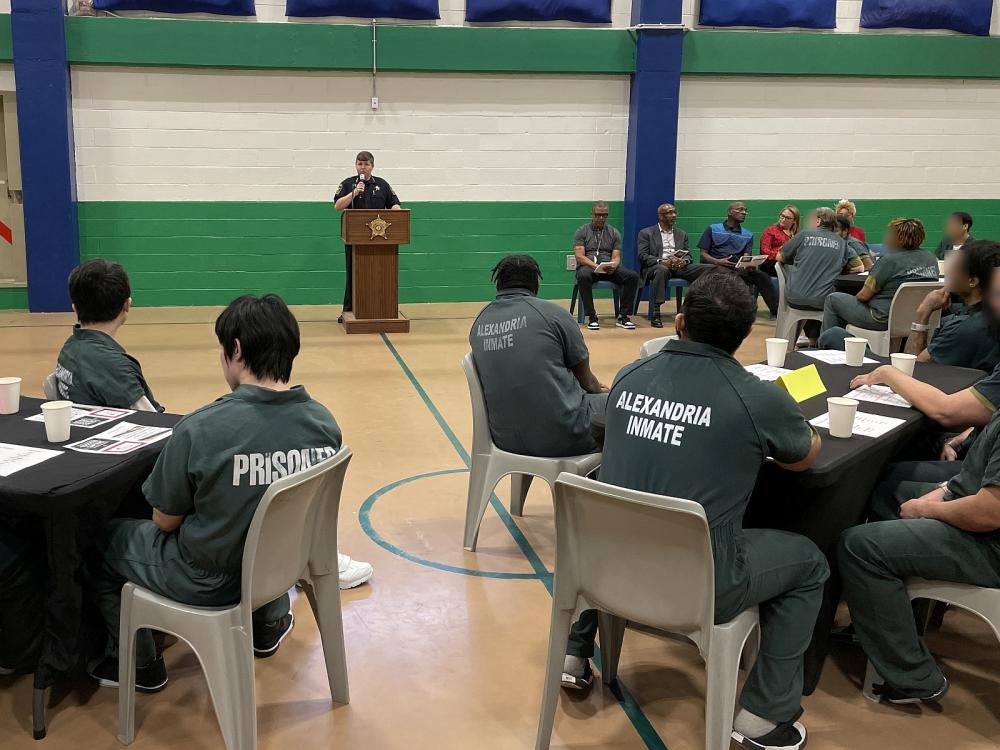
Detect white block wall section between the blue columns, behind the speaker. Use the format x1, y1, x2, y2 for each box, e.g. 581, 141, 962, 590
72, 67, 629, 201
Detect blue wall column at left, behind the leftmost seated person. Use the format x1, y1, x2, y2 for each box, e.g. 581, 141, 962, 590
11, 0, 80, 312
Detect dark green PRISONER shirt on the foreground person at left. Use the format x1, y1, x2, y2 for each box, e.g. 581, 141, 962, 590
142, 385, 341, 575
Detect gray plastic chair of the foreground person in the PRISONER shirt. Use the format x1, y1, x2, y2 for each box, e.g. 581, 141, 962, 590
118, 448, 351, 750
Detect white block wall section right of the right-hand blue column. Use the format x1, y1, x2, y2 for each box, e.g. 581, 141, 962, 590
677, 77, 1000, 200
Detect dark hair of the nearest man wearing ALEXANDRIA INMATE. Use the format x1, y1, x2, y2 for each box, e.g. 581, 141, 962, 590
681, 268, 757, 354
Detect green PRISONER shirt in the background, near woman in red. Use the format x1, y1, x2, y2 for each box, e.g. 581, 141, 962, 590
781, 229, 861, 310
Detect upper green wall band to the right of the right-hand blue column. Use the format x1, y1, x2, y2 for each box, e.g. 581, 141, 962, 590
681, 31, 1000, 78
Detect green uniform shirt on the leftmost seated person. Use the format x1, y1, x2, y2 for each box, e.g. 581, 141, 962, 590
56, 323, 163, 411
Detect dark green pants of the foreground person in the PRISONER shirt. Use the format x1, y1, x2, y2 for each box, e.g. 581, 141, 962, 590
93, 518, 290, 666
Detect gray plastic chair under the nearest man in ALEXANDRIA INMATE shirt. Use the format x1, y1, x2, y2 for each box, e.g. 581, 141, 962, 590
535, 474, 757, 750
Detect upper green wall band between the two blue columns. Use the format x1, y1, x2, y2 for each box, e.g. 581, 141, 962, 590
66, 16, 635, 75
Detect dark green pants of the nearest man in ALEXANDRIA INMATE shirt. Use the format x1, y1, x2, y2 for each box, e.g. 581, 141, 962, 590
566, 529, 830, 722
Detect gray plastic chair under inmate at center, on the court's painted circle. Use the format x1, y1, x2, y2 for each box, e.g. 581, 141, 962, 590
462, 352, 601, 552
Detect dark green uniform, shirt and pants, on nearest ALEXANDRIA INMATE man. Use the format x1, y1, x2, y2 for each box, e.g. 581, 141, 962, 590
567, 341, 829, 723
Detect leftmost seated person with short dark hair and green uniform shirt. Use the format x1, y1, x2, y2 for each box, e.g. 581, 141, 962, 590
55, 258, 163, 411
